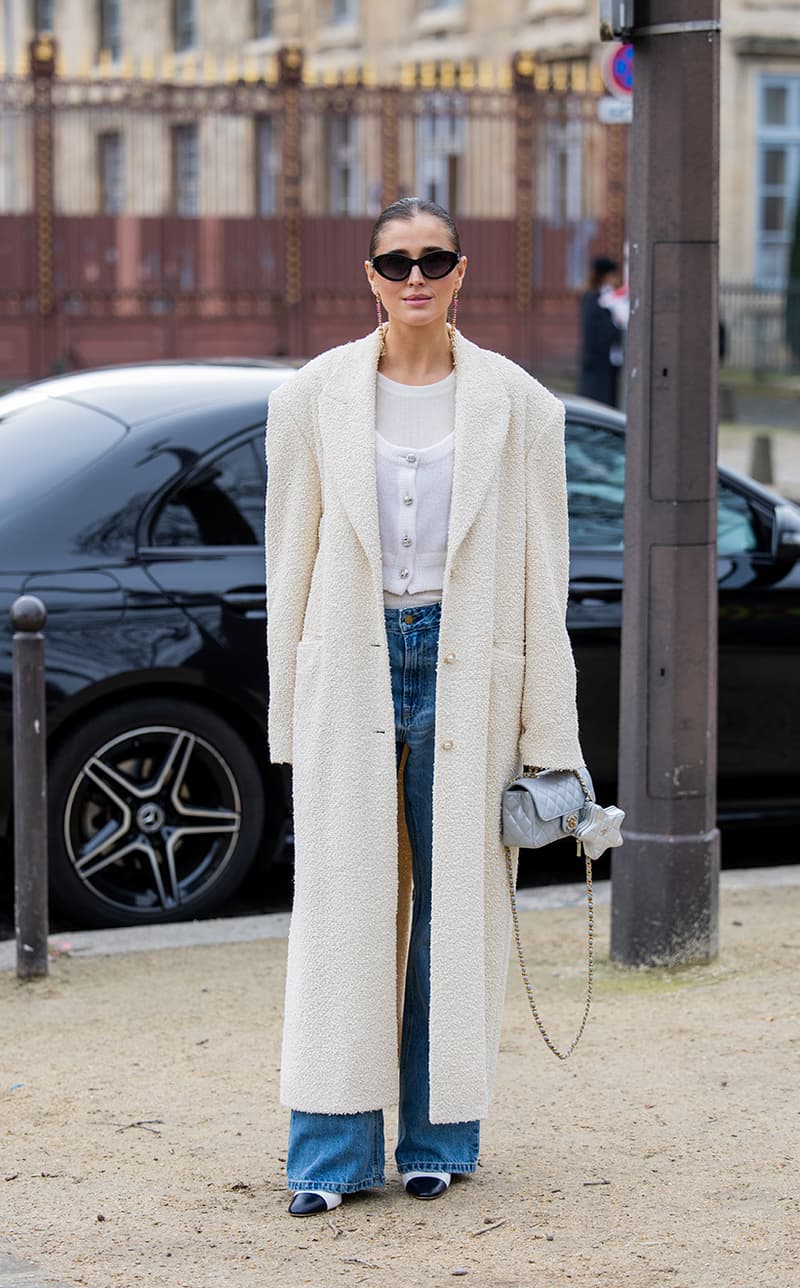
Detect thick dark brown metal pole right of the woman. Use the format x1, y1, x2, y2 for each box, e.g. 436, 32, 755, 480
611, 0, 719, 965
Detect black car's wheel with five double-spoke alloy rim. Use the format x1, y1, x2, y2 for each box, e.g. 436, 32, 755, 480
49, 699, 264, 926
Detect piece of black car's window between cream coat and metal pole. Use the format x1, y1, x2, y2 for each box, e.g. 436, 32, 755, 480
567, 421, 625, 550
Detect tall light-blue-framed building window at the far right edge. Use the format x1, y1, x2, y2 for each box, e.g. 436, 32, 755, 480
756, 76, 800, 287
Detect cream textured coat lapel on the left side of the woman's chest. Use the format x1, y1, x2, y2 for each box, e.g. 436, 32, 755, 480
319, 331, 381, 578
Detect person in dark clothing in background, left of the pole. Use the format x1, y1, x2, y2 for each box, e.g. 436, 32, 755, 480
578, 255, 627, 407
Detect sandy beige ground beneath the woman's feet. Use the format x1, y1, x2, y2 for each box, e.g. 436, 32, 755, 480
0, 886, 800, 1288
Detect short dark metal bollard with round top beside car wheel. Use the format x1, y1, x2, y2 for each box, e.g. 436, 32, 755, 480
9, 595, 49, 979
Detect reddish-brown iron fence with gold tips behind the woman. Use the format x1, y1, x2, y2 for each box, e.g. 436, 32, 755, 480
0, 39, 626, 377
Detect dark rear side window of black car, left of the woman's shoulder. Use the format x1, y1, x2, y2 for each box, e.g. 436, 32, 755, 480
151, 434, 265, 546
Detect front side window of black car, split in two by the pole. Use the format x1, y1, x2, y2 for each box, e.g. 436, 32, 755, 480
567, 421, 759, 555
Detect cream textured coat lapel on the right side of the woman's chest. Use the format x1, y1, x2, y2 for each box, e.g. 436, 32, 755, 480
447, 335, 510, 565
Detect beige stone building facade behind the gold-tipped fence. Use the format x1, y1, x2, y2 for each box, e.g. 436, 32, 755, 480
0, 0, 800, 286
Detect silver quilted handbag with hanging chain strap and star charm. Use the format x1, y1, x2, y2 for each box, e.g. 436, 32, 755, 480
502, 766, 625, 1060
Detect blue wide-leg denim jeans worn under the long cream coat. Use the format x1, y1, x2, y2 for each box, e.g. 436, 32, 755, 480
286, 604, 481, 1194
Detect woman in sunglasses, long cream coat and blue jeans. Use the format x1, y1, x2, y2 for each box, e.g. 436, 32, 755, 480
267, 197, 582, 1216
